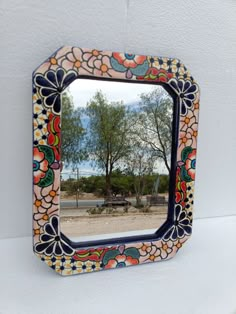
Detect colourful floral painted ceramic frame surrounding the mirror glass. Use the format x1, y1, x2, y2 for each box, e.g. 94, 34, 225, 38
33, 47, 199, 275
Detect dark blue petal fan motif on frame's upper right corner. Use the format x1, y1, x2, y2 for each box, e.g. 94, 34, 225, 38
168, 79, 198, 115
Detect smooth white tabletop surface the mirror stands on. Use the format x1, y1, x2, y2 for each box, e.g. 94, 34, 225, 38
0, 216, 236, 314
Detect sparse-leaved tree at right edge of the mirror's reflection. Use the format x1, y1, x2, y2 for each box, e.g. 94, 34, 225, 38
135, 87, 173, 172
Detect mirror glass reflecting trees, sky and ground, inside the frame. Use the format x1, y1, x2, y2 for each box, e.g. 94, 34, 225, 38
60, 79, 174, 241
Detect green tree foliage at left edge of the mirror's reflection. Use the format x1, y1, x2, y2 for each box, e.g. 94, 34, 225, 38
61, 92, 84, 166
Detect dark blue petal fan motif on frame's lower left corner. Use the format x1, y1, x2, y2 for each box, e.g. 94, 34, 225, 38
35, 216, 74, 256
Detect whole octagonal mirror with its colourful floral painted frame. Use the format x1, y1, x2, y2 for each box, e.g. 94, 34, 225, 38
33, 47, 199, 275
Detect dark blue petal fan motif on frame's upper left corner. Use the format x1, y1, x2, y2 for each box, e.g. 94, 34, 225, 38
34, 68, 78, 114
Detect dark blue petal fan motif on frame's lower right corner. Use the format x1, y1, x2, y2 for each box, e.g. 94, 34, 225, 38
163, 204, 192, 241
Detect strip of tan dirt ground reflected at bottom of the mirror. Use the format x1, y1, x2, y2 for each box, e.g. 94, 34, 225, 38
61, 209, 167, 237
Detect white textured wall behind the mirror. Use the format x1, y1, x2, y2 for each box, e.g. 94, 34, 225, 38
0, 0, 236, 238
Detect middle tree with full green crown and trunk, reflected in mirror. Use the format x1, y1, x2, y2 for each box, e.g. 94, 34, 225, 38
86, 92, 133, 196
